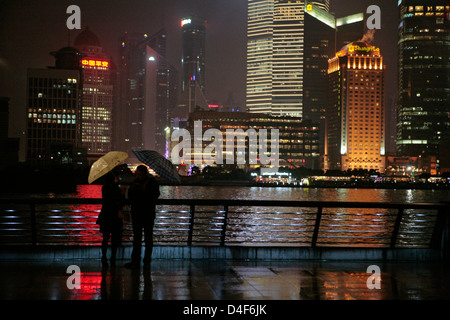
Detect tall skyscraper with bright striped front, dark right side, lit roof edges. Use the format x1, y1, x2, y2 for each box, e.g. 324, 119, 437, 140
246, 0, 364, 153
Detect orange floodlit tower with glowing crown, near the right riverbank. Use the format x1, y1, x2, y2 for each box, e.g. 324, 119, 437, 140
325, 41, 385, 172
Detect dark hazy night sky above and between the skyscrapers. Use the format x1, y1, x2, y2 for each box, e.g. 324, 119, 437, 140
0, 0, 398, 160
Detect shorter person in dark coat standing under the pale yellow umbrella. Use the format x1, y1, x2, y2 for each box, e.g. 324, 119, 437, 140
97, 172, 126, 266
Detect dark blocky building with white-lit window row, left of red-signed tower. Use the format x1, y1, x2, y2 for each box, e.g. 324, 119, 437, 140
27, 47, 82, 165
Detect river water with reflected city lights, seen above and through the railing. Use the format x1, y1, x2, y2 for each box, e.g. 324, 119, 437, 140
0, 185, 450, 246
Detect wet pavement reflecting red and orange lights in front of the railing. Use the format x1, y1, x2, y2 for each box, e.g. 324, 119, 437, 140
0, 259, 450, 301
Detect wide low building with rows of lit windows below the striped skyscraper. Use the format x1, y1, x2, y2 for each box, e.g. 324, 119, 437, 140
181, 111, 320, 170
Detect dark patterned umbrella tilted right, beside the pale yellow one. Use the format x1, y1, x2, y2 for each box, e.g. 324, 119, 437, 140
133, 150, 181, 183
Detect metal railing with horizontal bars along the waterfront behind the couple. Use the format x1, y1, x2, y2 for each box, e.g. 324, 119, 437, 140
0, 198, 449, 250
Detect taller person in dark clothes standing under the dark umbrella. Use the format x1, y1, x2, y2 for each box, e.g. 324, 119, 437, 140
125, 165, 160, 268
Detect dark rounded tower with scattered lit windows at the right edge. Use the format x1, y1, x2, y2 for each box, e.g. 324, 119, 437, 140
397, 0, 450, 173
